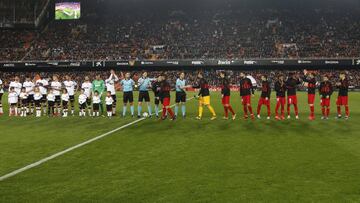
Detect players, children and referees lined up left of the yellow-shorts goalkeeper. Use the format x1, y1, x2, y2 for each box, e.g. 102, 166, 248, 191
0, 70, 188, 118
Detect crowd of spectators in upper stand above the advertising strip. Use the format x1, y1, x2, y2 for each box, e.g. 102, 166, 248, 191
0, 6, 360, 60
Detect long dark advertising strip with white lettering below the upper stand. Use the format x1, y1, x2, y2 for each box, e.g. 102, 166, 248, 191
0, 59, 360, 68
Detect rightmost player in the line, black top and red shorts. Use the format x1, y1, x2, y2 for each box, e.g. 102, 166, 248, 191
336, 73, 350, 119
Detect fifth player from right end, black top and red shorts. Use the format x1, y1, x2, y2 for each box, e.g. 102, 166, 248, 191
275, 75, 286, 120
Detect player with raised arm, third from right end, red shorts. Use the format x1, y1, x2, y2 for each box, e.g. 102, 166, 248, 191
303, 70, 316, 120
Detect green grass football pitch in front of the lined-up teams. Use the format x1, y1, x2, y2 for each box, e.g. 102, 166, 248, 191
0, 92, 360, 202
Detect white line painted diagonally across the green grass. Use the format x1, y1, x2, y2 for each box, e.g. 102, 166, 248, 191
0, 97, 193, 182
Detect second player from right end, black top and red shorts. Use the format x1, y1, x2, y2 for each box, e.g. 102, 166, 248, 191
319, 75, 333, 119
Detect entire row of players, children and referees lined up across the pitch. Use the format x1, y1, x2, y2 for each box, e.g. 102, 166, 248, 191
0, 70, 349, 120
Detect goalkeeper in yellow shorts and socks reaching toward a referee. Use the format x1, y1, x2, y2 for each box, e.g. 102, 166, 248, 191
193, 73, 216, 120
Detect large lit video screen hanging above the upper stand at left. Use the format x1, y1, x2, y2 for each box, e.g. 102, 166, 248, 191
55, 2, 81, 20
